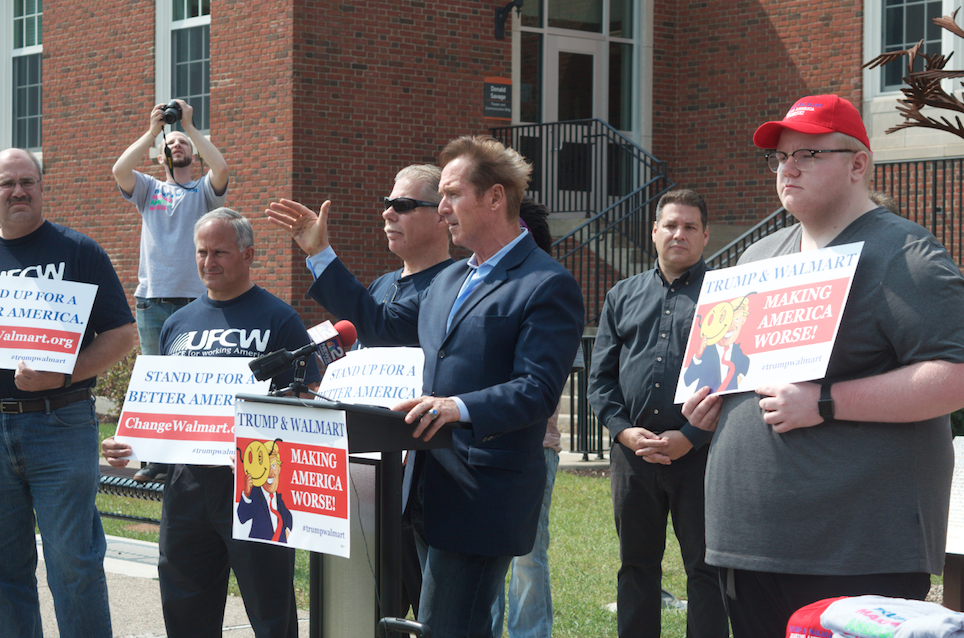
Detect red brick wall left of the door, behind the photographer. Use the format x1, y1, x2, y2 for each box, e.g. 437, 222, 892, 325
38, 0, 511, 330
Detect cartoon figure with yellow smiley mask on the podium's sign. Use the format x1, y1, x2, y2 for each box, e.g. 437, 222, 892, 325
238, 439, 293, 543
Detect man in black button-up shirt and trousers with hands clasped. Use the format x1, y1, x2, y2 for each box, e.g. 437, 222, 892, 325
589, 190, 728, 638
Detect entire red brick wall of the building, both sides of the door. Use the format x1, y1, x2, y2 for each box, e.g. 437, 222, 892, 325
37, 0, 863, 336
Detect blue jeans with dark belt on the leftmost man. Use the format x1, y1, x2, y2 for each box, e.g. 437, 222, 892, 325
0, 399, 113, 638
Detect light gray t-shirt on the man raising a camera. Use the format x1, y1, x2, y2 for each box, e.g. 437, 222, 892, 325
120, 171, 228, 298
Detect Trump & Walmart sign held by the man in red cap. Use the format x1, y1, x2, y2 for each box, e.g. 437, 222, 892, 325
675, 242, 863, 403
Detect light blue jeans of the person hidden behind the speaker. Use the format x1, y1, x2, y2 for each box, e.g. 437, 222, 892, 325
492, 448, 559, 638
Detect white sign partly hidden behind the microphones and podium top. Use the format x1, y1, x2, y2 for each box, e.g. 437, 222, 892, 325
318, 348, 425, 408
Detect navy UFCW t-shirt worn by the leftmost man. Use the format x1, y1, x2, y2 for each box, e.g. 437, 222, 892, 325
0, 221, 134, 399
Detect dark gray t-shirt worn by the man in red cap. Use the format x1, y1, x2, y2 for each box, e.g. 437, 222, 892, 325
706, 208, 964, 575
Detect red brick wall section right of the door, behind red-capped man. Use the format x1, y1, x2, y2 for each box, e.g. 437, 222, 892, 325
652, 0, 863, 224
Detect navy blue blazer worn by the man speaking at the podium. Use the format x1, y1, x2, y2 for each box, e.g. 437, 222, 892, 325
308, 236, 583, 556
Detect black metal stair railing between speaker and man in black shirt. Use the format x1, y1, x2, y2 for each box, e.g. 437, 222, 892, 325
491, 119, 674, 325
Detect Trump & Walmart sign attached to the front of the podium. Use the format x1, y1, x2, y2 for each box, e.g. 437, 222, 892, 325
233, 400, 350, 558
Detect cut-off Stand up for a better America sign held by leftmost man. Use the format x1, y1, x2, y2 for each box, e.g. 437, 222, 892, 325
0, 280, 97, 374
